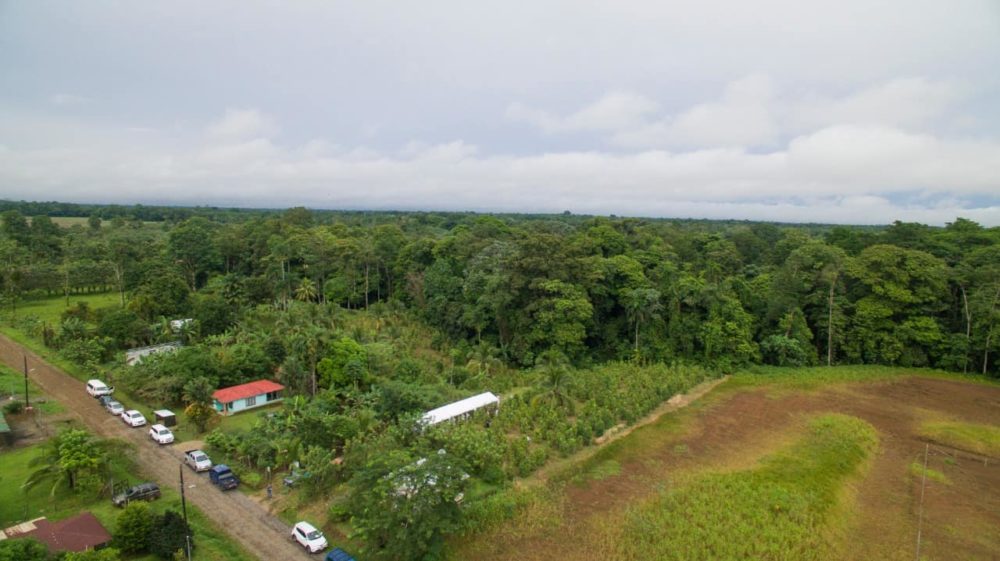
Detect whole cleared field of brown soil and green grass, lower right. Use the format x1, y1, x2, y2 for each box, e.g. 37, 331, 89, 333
452, 369, 1000, 561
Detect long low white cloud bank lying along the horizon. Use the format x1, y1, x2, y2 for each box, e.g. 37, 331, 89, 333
0, 107, 1000, 225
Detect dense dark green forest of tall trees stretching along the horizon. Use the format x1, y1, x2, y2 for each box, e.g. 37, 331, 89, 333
0, 202, 1000, 375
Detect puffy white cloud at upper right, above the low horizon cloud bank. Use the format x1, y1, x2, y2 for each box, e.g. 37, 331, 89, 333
507, 75, 969, 149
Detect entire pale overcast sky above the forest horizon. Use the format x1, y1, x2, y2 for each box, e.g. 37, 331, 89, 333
0, 0, 1000, 226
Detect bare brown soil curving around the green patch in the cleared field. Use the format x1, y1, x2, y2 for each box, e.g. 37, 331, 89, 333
463, 377, 1000, 561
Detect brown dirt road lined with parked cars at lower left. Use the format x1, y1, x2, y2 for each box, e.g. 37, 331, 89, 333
0, 335, 314, 561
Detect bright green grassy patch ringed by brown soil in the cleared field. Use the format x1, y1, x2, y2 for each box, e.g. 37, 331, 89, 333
602, 414, 878, 561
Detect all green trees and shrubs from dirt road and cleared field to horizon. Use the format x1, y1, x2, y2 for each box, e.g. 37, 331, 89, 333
0, 202, 1000, 559
